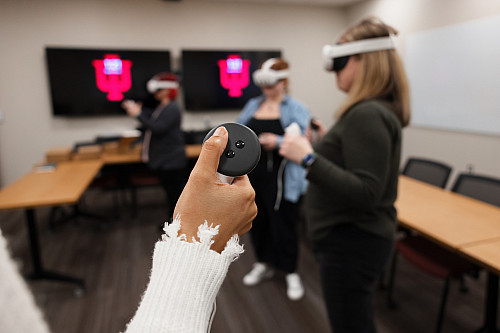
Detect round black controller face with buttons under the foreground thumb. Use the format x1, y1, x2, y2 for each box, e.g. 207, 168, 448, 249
203, 123, 260, 177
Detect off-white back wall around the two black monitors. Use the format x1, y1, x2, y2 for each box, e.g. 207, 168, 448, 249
0, 0, 346, 186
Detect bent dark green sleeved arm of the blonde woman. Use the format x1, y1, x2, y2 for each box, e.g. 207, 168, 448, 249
307, 107, 396, 209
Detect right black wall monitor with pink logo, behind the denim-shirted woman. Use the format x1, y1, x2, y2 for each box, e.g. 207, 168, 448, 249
182, 50, 281, 111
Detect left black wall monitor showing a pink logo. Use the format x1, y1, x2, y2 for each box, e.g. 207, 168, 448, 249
45, 47, 170, 116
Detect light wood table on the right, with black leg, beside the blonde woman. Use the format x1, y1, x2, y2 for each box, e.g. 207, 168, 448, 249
396, 176, 500, 333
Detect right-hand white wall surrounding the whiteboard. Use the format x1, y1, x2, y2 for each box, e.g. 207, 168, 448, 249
347, 0, 500, 183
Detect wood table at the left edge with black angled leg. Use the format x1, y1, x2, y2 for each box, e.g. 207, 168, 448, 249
0, 160, 102, 291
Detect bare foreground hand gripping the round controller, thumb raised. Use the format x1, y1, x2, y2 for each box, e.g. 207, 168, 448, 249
173, 126, 257, 253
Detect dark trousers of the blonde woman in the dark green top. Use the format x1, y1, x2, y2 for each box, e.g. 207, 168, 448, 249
315, 225, 393, 333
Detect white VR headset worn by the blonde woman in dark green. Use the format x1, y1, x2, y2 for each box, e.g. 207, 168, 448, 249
323, 36, 396, 71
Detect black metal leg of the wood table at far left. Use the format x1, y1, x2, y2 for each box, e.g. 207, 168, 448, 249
26, 208, 85, 290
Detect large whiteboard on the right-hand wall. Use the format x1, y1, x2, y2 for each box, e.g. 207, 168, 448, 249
405, 16, 500, 135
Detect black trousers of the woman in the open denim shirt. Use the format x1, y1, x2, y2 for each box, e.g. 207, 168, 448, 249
250, 195, 299, 273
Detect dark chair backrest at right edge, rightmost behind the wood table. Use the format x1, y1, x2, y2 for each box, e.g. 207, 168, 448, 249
451, 173, 500, 207
